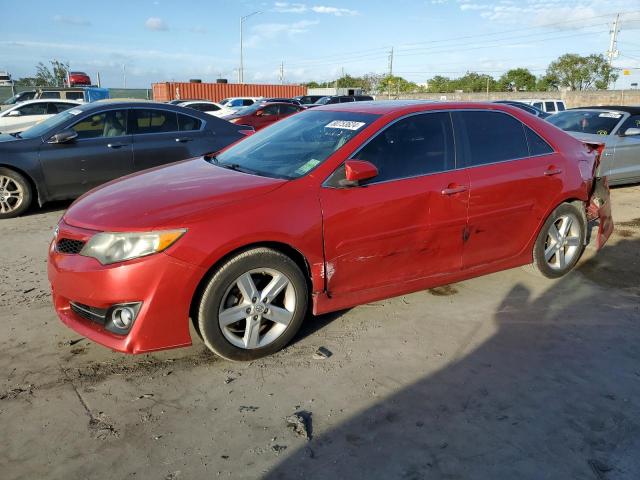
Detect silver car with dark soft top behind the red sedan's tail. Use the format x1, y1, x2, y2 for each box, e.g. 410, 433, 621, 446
547, 106, 640, 185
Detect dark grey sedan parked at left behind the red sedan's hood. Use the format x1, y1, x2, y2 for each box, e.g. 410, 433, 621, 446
0, 102, 245, 219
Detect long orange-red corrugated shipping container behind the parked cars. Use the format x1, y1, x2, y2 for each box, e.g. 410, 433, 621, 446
153, 82, 307, 102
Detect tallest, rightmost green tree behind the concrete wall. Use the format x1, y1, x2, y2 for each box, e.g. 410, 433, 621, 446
547, 53, 618, 90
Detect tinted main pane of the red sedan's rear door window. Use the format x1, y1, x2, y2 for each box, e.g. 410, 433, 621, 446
454, 111, 529, 166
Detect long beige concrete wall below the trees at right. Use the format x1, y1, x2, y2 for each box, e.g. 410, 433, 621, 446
392, 90, 640, 108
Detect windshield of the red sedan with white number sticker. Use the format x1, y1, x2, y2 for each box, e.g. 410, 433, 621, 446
214, 110, 379, 179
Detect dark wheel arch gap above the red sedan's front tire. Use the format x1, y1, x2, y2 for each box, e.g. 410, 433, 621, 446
189, 241, 312, 334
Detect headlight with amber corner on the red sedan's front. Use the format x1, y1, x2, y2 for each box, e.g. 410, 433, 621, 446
80, 229, 186, 265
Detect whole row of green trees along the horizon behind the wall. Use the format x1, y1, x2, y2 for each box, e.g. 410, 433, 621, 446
303, 53, 618, 94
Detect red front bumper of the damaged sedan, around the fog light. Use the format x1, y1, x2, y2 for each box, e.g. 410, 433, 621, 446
48, 222, 205, 353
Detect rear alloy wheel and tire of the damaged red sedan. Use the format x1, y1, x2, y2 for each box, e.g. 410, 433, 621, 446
532, 203, 587, 278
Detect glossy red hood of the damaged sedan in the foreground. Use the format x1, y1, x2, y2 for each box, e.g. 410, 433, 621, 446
64, 157, 286, 231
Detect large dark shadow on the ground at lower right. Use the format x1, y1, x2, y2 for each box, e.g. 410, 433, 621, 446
264, 238, 640, 480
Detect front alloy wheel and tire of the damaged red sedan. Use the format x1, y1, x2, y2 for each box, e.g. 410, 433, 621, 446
197, 248, 308, 361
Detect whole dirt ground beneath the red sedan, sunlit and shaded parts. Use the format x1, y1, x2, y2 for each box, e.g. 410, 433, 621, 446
0, 186, 640, 480
